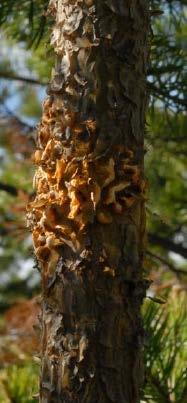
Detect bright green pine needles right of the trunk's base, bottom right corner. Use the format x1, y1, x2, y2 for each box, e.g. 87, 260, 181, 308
142, 293, 187, 403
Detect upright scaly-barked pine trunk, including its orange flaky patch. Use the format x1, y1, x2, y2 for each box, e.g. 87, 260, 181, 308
28, 0, 149, 403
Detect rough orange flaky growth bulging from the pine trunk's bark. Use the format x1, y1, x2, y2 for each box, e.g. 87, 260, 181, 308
27, 97, 145, 272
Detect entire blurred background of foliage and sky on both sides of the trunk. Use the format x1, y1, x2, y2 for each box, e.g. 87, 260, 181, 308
0, 0, 187, 403
